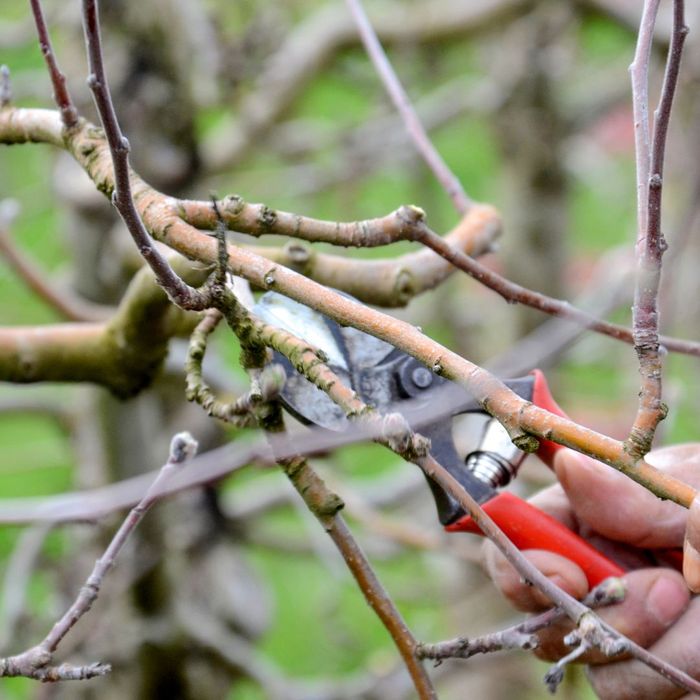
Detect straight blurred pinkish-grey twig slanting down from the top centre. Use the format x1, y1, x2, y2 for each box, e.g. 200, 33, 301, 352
346, 0, 472, 214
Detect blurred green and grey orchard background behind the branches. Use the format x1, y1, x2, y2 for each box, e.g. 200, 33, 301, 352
0, 0, 700, 700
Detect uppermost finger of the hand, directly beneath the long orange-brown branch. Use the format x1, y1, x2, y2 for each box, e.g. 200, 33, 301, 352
554, 445, 700, 548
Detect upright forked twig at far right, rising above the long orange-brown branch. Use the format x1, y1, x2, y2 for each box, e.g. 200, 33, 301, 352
627, 0, 688, 456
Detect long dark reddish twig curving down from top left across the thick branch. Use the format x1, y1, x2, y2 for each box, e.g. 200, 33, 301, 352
83, 0, 207, 309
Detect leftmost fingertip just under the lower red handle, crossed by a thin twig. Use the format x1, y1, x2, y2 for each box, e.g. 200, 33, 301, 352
483, 540, 588, 612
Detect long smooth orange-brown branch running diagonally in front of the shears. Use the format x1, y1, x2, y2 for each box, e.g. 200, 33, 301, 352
0, 109, 700, 507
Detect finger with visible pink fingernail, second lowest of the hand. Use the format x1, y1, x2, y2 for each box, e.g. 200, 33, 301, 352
537, 568, 690, 663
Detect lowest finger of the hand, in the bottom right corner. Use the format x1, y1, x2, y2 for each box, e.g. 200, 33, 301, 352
588, 598, 700, 700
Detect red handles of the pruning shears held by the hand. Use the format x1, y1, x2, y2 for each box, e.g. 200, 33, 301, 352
452, 369, 624, 588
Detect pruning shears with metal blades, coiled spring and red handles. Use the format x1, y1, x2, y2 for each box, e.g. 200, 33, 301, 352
254, 292, 624, 587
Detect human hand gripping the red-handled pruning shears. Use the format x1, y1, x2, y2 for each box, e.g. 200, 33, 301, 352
484, 444, 700, 700
